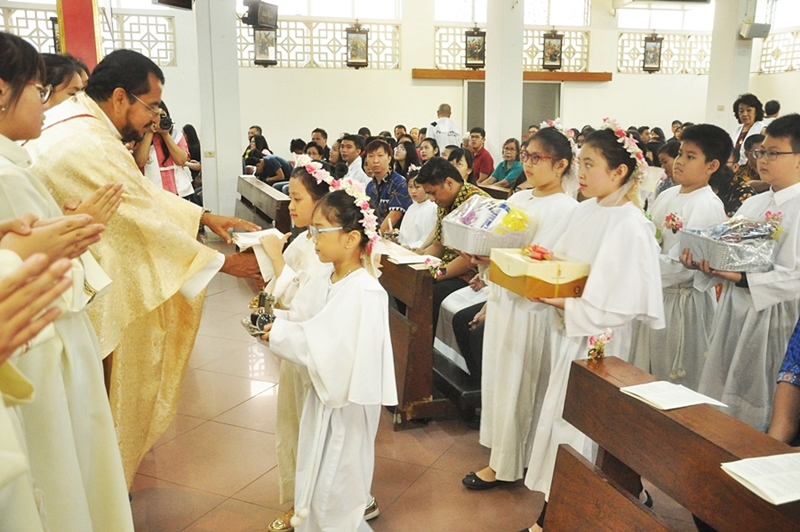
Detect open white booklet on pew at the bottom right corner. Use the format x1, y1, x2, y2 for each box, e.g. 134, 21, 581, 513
721, 453, 800, 504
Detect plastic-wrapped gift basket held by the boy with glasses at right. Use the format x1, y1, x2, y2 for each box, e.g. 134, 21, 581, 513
681, 216, 781, 273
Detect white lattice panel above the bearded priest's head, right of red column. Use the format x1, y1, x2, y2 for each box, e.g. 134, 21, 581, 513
101, 13, 178, 66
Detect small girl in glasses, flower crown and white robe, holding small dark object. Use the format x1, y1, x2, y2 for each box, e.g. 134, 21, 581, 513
263, 187, 397, 532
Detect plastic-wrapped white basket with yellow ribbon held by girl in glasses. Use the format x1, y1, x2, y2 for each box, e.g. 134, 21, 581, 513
442, 195, 531, 255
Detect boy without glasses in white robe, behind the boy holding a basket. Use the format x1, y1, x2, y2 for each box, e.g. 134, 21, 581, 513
631, 124, 733, 390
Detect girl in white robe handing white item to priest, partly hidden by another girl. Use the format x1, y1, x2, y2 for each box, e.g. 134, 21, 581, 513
261, 159, 336, 530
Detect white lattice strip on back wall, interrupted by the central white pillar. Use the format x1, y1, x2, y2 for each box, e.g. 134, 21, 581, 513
434, 26, 589, 72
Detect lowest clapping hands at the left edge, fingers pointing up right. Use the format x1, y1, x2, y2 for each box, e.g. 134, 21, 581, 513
0, 251, 72, 364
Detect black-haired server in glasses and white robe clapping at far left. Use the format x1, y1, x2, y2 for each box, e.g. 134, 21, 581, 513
0, 33, 133, 532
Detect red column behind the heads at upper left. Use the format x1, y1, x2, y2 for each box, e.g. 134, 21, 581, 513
58, 0, 100, 71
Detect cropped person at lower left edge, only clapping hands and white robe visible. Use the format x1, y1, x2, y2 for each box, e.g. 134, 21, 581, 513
0, 249, 72, 532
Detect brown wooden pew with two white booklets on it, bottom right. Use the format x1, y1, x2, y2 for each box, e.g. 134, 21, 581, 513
545, 357, 800, 532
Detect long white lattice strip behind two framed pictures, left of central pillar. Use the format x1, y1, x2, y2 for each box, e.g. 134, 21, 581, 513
237, 20, 400, 70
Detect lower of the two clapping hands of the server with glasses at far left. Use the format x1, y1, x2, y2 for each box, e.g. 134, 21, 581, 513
0, 214, 105, 260
